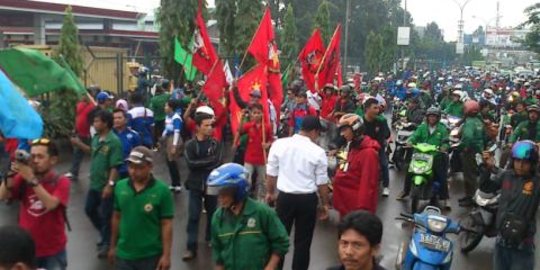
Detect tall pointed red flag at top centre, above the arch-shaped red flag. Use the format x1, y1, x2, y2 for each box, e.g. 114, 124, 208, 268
248, 7, 280, 73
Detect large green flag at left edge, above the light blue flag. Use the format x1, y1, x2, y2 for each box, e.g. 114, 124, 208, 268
0, 48, 86, 97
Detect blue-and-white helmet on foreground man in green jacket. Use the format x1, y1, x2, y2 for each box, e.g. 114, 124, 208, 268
207, 163, 249, 202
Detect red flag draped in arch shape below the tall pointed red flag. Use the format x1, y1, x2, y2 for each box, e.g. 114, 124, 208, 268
229, 65, 270, 134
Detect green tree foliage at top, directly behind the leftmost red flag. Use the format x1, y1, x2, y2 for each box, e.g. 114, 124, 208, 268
157, 0, 206, 81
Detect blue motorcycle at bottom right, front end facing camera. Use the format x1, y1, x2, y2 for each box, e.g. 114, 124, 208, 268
396, 206, 470, 270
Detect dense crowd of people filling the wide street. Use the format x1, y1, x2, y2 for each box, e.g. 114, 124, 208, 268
0, 69, 540, 270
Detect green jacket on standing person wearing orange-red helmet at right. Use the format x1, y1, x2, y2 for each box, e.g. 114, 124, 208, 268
460, 117, 487, 153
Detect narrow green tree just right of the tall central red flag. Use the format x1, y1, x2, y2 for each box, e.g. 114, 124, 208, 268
280, 4, 298, 67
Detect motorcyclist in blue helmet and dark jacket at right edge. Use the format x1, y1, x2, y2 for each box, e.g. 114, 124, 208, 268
483, 141, 540, 270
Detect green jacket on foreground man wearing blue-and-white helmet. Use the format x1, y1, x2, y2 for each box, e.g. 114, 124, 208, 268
212, 198, 289, 270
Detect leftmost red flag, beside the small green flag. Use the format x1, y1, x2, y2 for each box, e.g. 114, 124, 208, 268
192, 9, 218, 75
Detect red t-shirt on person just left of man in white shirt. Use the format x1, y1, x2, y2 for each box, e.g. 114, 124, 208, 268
244, 121, 273, 165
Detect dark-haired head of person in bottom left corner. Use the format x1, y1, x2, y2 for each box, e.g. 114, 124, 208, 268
0, 226, 37, 270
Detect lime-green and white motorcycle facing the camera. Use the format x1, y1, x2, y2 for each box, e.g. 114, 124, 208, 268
408, 143, 440, 213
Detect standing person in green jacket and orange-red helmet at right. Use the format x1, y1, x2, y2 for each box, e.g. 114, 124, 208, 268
458, 100, 487, 207
